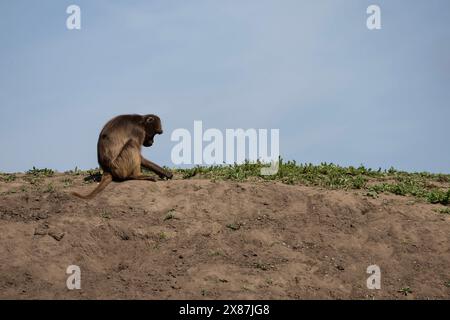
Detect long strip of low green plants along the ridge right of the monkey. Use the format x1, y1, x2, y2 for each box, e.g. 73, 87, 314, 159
175, 159, 450, 205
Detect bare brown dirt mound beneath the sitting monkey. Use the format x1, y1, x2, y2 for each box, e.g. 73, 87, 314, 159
0, 174, 450, 299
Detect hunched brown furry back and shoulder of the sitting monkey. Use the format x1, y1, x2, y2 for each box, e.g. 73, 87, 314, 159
97, 115, 145, 171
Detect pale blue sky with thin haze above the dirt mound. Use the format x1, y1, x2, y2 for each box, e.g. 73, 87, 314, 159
0, 0, 450, 173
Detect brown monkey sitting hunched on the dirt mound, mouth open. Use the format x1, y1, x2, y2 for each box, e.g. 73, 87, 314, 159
73, 114, 172, 199
